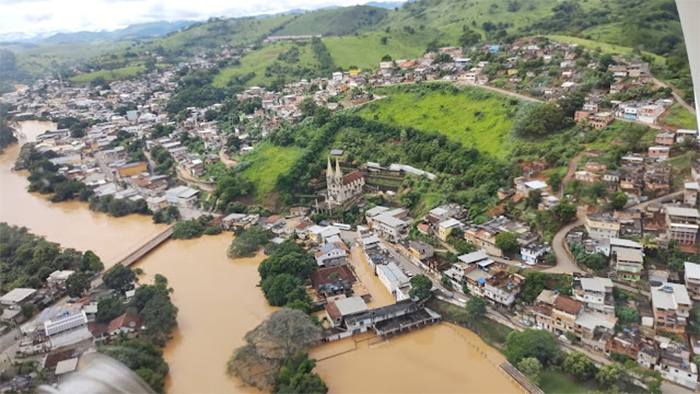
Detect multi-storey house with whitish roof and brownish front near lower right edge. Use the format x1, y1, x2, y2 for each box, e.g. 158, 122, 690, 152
651, 283, 692, 335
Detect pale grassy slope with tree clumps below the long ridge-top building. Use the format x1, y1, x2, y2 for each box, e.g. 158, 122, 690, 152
213, 42, 314, 87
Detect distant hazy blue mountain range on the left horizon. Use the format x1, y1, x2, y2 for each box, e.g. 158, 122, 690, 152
0, 21, 195, 44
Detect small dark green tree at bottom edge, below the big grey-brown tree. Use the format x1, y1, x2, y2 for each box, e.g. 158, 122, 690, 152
276, 353, 328, 394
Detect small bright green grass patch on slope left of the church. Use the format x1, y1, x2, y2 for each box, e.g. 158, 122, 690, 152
243, 142, 303, 202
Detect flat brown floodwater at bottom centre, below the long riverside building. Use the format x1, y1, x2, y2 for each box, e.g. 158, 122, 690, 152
311, 323, 522, 393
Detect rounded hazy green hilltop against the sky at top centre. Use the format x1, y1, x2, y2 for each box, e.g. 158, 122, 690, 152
275, 6, 389, 36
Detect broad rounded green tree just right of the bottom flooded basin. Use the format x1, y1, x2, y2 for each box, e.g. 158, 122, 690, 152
506, 329, 561, 365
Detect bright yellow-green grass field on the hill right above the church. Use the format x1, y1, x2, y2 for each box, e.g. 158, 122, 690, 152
359, 85, 519, 157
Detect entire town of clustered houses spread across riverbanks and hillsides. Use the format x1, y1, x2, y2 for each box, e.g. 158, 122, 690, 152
0, 6, 700, 392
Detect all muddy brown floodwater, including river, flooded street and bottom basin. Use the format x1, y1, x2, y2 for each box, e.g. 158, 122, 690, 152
0, 122, 519, 393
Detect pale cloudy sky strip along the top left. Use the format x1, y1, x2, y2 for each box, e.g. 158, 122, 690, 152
0, 0, 378, 36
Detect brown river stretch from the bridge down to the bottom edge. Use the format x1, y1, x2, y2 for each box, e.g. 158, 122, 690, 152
131, 233, 273, 393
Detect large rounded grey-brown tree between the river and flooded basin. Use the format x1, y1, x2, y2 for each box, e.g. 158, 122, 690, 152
227, 308, 321, 390
